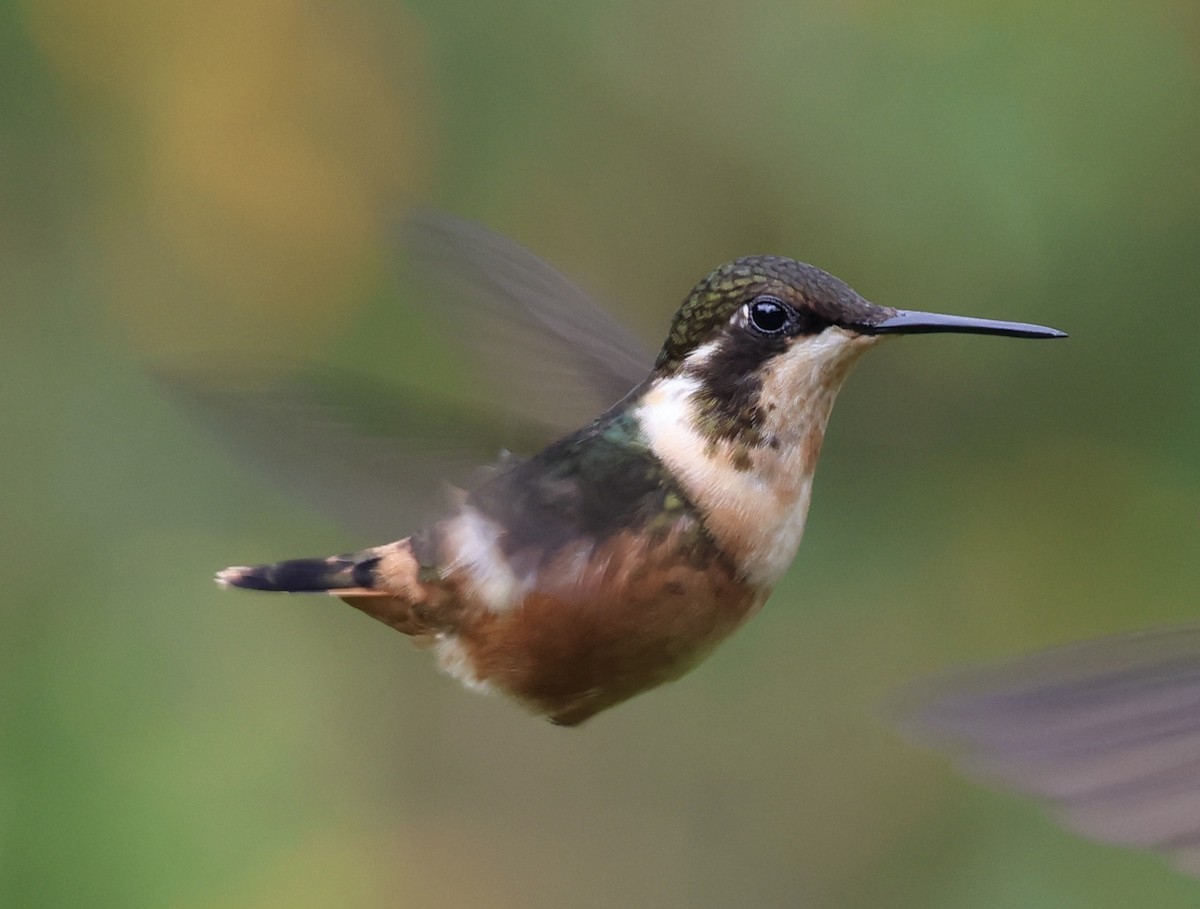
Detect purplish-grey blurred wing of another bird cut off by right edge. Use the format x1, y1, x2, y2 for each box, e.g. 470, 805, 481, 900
901, 626, 1200, 877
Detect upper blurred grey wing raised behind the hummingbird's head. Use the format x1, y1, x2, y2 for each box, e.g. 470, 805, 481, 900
402, 212, 654, 433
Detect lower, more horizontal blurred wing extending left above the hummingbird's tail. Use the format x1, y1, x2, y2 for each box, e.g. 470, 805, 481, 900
156, 371, 547, 542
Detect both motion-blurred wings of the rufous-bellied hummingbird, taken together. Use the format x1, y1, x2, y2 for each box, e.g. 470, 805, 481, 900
156, 212, 653, 538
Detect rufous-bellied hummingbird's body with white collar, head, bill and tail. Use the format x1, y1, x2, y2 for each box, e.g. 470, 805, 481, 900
216, 213, 1064, 726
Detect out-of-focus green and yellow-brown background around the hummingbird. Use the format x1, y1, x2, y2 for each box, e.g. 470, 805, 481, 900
7, 0, 1200, 909
